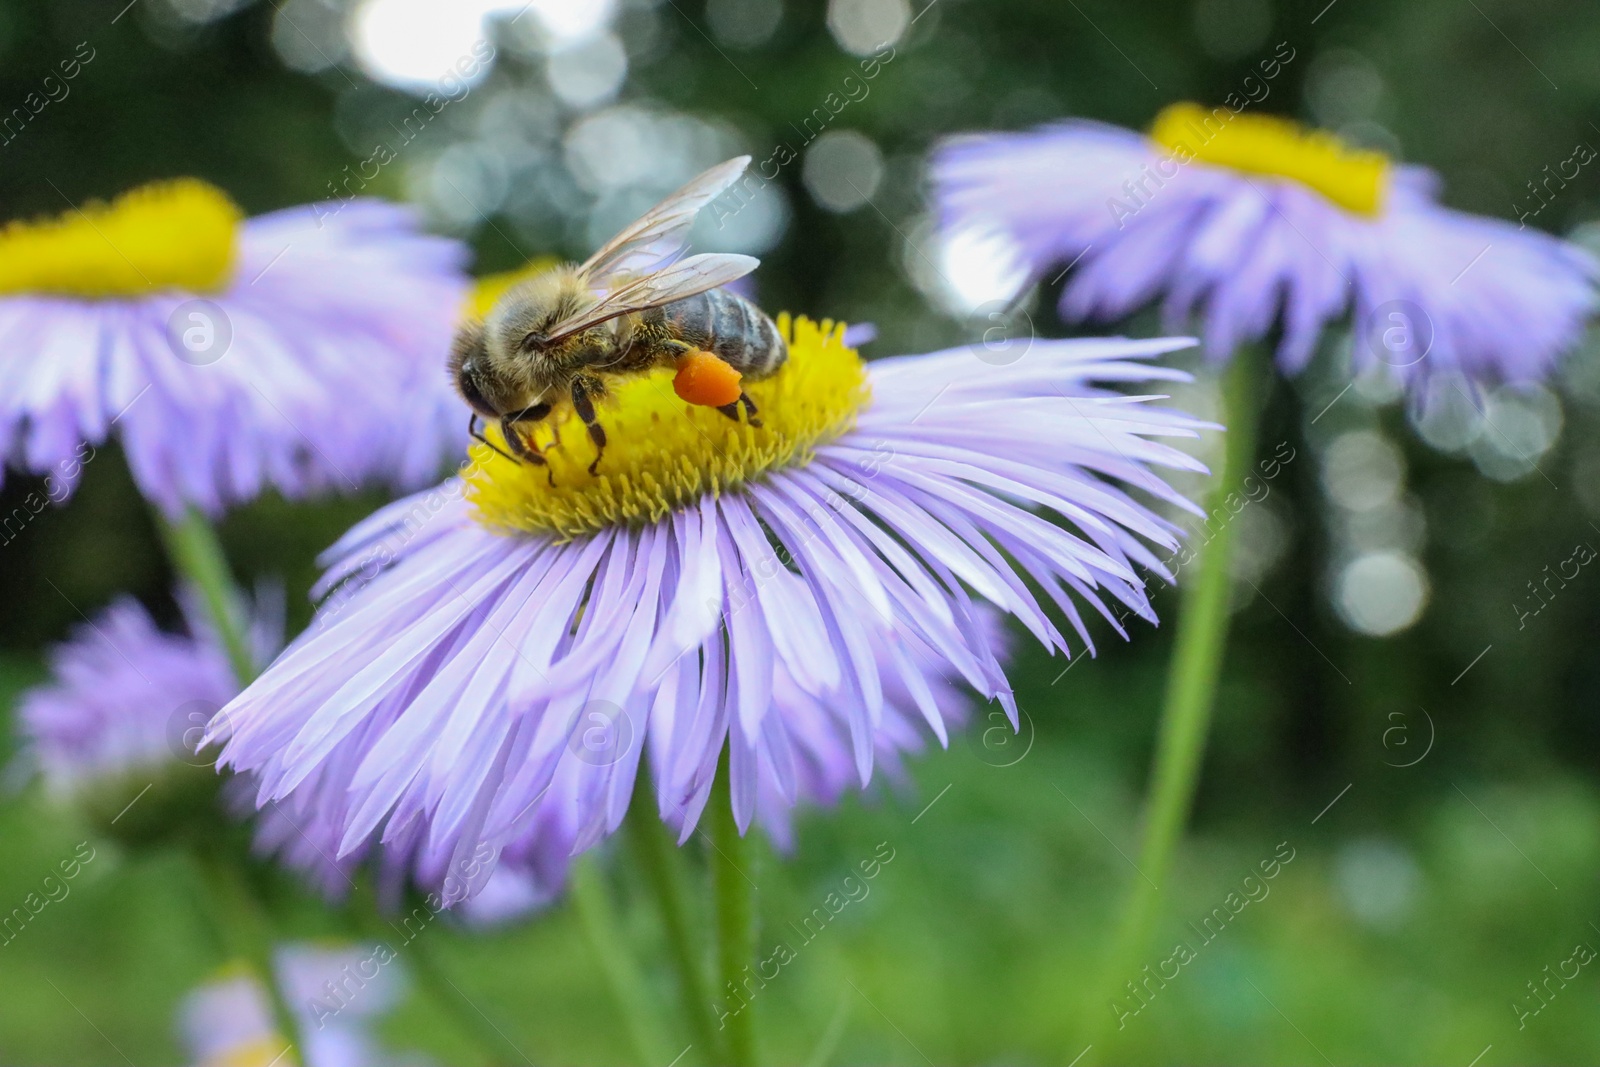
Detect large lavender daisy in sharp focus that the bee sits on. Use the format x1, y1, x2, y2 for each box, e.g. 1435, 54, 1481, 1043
208, 317, 1202, 888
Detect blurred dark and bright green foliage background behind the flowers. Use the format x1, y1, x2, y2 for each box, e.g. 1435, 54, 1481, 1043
0, 0, 1600, 1065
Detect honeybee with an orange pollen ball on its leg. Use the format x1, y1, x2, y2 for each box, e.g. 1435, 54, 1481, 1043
450, 155, 789, 475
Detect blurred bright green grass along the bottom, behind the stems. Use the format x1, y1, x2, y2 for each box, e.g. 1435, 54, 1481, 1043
0, 633, 1600, 1064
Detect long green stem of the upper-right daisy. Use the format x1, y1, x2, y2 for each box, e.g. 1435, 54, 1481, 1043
1090, 347, 1261, 1033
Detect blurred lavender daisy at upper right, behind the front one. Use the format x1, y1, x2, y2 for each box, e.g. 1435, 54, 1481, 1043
933, 104, 1600, 382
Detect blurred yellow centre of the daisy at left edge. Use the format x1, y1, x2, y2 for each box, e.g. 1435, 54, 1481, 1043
0, 178, 245, 298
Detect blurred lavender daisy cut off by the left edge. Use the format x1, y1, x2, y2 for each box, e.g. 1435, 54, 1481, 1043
0, 179, 466, 515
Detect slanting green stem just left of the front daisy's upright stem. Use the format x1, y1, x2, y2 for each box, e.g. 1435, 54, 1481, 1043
627, 766, 726, 1064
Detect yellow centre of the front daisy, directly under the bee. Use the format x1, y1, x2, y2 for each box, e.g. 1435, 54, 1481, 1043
466, 314, 870, 537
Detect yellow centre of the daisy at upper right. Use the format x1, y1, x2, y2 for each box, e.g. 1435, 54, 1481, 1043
1150, 102, 1389, 218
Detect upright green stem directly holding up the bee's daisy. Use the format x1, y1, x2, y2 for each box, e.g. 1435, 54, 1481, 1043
707, 750, 755, 1067
